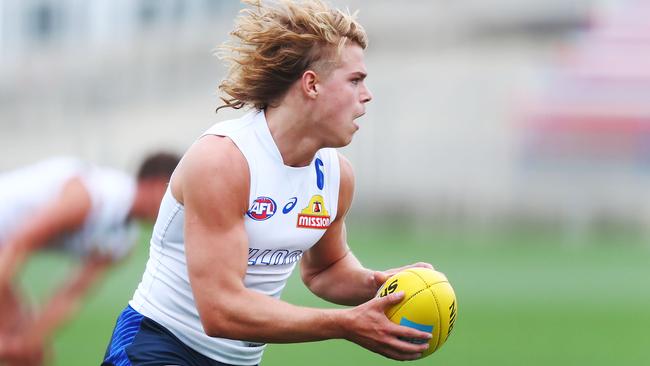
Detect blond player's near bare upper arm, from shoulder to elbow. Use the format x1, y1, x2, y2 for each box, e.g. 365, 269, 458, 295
176, 137, 248, 321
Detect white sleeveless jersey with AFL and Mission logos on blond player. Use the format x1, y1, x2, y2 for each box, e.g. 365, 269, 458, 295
130, 112, 340, 365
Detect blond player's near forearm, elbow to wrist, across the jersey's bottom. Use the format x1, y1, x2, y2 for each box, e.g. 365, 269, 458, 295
197, 289, 349, 343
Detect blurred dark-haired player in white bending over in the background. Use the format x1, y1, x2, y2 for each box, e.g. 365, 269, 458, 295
0, 153, 178, 365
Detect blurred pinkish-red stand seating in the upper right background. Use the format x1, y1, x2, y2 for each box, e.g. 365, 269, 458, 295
522, 1, 650, 162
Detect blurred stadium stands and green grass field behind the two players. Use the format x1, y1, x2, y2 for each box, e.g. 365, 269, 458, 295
0, 0, 650, 365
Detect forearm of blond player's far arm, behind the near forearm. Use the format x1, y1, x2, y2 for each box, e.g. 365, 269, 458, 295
303, 252, 377, 305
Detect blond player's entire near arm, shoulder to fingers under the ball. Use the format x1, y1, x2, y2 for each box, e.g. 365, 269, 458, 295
177, 136, 428, 359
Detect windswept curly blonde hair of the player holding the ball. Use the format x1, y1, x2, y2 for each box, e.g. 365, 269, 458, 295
217, 0, 368, 111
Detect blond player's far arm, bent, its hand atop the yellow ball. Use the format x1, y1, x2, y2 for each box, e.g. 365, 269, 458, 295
300, 155, 432, 305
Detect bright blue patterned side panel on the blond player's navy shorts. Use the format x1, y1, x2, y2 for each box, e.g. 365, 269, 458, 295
104, 305, 144, 366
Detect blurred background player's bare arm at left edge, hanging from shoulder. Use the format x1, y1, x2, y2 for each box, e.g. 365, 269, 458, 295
0, 178, 91, 287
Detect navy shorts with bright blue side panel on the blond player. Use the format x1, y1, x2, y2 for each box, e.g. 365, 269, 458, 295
102, 306, 253, 366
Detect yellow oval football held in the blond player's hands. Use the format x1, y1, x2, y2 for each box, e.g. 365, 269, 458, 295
377, 268, 458, 358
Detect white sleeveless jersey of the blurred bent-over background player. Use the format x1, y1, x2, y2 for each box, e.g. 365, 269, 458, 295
0, 157, 138, 260
